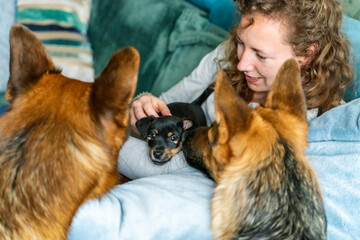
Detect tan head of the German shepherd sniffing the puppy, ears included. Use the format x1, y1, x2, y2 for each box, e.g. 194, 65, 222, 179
183, 60, 307, 181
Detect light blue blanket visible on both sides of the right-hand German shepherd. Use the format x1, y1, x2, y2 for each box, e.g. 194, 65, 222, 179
69, 99, 360, 240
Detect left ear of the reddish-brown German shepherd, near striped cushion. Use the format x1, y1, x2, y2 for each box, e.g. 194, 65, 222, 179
6, 24, 60, 102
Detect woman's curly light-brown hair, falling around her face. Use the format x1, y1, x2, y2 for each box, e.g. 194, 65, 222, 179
223, 0, 352, 114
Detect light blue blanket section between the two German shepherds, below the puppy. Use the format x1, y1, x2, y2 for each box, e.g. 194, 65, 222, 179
68, 167, 214, 240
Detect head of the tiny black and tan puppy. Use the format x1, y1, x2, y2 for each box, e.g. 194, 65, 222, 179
136, 116, 192, 164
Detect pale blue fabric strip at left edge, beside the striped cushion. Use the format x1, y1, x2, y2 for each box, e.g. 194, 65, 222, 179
0, 0, 17, 92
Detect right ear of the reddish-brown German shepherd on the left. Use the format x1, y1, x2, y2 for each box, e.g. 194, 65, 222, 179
92, 47, 140, 122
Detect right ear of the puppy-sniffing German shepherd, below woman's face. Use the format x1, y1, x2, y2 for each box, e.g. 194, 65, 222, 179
265, 59, 306, 121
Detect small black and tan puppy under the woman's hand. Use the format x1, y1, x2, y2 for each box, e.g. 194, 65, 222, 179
136, 84, 213, 165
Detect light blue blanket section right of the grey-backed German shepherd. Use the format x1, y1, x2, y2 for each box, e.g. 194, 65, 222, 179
307, 99, 360, 240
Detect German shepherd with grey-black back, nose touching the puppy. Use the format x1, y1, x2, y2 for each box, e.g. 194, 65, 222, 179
183, 59, 326, 240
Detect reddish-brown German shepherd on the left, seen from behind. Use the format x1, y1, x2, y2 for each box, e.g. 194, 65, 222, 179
0, 25, 139, 240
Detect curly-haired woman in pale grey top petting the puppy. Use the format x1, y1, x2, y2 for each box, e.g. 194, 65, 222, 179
119, 0, 352, 178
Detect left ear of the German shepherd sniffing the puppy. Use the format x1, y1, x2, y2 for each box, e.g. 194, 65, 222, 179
214, 71, 251, 144
